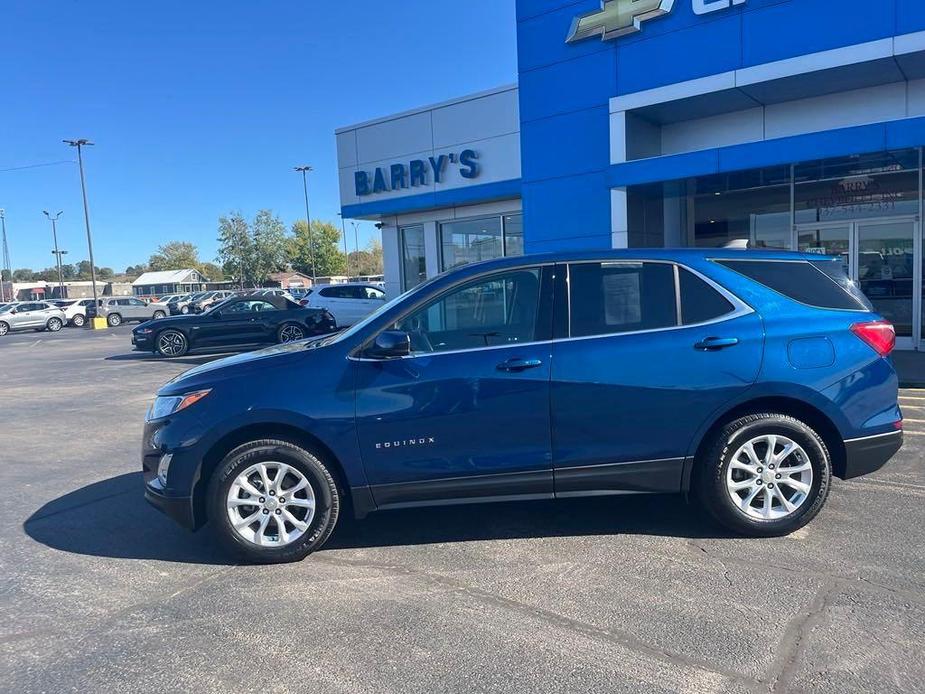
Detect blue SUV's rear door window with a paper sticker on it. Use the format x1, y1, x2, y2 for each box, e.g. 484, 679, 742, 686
569, 261, 678, 337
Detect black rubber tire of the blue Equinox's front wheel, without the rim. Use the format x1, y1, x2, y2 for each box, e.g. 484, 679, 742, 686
206, 439, 341, 564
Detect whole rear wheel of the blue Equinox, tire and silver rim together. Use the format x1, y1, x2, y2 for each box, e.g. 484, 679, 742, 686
698, 413, 832, 537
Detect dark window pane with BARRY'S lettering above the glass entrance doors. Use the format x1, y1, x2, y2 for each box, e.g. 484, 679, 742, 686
794, 149, 919, 224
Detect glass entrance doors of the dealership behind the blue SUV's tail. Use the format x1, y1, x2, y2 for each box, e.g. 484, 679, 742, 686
797, 218, 922, 349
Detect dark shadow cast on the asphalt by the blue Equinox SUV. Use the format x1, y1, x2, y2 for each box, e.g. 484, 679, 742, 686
23, 472, 728, 565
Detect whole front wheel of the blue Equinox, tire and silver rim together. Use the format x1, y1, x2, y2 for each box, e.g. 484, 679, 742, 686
207, 440, 340, 564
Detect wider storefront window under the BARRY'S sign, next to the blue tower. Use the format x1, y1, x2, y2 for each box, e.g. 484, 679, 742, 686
440, 213, 523, 271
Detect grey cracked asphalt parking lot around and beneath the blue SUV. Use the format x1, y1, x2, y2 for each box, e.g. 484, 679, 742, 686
0, 327, 925, 694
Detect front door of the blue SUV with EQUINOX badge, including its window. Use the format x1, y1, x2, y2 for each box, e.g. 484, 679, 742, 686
355, 266, 553, 507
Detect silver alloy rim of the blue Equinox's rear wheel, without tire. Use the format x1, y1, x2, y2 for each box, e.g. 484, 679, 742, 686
726, 434, 813, 520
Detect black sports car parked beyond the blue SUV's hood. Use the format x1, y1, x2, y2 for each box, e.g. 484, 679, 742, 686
132, 296, 337, 357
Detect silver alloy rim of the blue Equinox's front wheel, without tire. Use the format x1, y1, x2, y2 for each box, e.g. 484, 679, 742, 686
226, 462, 315, 547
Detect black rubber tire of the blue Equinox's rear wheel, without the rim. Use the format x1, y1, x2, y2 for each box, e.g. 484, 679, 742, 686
696, 412, 832, 537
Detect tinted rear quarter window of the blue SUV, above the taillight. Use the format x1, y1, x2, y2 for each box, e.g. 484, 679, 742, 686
716, 260, 871, 311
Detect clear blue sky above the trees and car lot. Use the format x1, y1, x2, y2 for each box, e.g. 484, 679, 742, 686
0, 0, 516, 271
